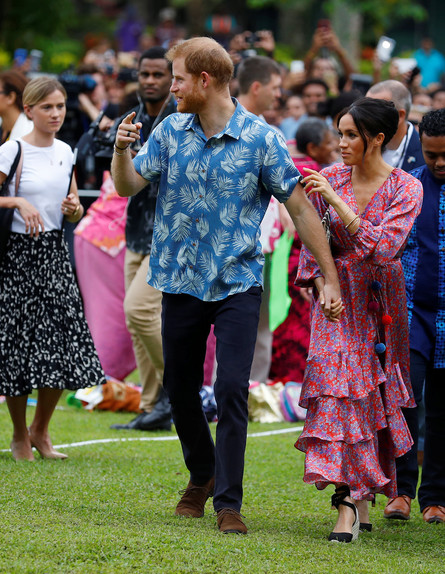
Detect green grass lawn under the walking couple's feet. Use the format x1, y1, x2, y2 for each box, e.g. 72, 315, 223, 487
0, 399, 445, 574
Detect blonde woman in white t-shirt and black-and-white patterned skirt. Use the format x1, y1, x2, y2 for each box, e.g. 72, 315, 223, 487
0, 77, 105, 460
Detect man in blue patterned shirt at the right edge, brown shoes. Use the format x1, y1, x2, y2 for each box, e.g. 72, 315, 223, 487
384, 108, 445, 523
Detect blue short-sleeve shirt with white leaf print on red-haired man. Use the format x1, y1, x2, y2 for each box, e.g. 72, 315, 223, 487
133, 100, 301, 301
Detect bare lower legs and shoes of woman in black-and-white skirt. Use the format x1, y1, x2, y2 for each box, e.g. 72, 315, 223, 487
6, 389, 67, 460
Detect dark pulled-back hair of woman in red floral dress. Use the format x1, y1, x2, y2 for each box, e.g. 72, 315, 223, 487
337, 97, 399, 155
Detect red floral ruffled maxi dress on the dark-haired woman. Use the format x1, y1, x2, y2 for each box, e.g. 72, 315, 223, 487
295, 164, 423, 500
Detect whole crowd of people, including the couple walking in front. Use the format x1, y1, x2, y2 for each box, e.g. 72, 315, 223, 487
0, 11, 445, 543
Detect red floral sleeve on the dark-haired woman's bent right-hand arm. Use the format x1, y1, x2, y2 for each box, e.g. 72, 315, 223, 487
346, 170, 423, 265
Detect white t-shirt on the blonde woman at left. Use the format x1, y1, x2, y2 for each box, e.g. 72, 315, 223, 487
0, 139, 73, 233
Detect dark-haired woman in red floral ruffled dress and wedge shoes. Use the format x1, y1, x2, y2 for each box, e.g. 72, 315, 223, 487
295, 98, 422, 542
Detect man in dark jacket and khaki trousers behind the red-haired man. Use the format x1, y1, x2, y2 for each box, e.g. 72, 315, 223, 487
108, 46, 176, 430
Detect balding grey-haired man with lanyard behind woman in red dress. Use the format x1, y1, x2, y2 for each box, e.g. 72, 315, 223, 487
366, 80, 425, 171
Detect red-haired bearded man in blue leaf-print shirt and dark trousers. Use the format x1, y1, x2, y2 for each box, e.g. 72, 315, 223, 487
112, 38, 342, 534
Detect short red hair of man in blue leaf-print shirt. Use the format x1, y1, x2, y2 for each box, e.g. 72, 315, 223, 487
165, 36, 233, 88
